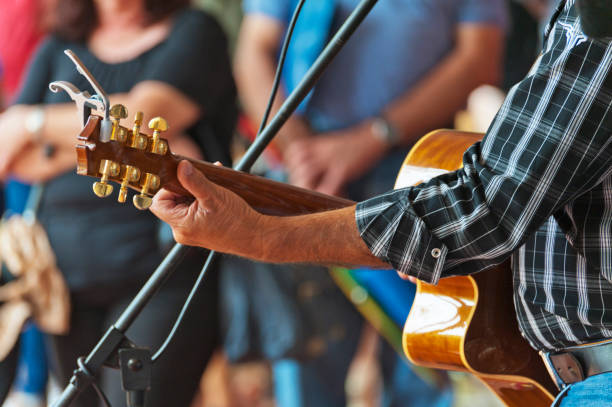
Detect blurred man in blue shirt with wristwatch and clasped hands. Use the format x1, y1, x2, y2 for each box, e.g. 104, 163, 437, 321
233, 0, 507, 406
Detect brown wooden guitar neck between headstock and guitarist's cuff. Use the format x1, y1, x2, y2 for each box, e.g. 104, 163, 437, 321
162, 155, 355, 216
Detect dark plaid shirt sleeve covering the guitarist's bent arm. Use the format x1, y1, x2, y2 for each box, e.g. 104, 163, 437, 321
356, 19, 612, 283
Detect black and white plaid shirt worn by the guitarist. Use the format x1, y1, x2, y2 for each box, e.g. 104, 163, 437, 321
356, 0, 612, 350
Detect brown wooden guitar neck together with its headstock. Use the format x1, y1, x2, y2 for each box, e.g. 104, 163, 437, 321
76, 115, 355, 216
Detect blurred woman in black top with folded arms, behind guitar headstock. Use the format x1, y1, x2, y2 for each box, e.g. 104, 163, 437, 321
0, 0, 235, 407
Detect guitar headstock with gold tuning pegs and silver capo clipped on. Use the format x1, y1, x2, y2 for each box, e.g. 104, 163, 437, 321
49, 50, 170, 210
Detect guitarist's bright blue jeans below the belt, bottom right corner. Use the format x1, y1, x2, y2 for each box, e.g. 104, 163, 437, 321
552, 372, 612, 407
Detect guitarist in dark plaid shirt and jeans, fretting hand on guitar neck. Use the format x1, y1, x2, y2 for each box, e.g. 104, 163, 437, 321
152, 0, 612, 406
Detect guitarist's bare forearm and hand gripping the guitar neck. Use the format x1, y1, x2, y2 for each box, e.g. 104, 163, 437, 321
151, 161, 389, 268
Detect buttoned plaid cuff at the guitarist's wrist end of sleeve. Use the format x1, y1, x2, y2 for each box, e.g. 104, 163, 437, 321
355, 190, 448, 284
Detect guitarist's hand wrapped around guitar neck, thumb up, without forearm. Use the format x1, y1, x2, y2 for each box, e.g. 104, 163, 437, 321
151, 161, 261, 257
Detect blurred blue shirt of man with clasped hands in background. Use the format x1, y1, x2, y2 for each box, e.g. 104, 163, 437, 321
244, 0, 507, 132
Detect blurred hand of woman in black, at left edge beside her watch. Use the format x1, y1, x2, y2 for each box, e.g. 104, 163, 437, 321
0, 105, 34, 179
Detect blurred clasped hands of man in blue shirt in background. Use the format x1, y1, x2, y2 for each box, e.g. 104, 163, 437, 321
283, 120, 387, 195
